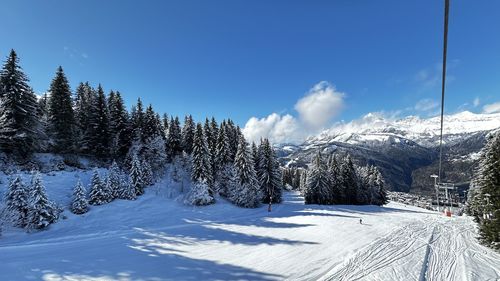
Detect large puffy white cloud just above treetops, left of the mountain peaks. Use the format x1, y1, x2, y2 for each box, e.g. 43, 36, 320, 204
243, 81, 344, 143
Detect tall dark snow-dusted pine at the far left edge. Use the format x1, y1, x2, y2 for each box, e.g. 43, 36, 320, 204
0, 50, 41, 158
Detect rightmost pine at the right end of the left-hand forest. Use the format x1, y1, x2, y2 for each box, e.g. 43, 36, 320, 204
258, 139, 282, 203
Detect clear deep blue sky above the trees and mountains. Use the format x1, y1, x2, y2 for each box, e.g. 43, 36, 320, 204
0, 0, 500, 140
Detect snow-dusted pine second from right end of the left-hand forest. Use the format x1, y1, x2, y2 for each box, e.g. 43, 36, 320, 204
229, 135, 262, 208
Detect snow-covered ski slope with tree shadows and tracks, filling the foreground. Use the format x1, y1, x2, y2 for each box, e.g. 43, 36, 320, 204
0, 172, 500, 281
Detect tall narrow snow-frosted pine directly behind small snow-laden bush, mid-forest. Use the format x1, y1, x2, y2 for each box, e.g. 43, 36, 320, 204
191, 123, 213, 191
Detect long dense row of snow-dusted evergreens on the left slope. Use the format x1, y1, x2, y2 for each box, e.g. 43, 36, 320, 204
0, 50, 282, 232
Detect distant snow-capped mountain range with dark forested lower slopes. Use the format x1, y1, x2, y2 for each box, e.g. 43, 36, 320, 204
278, 111, 500, 193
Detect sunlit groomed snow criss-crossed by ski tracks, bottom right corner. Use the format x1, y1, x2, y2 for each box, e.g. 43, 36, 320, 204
320, 212, 500, 281
